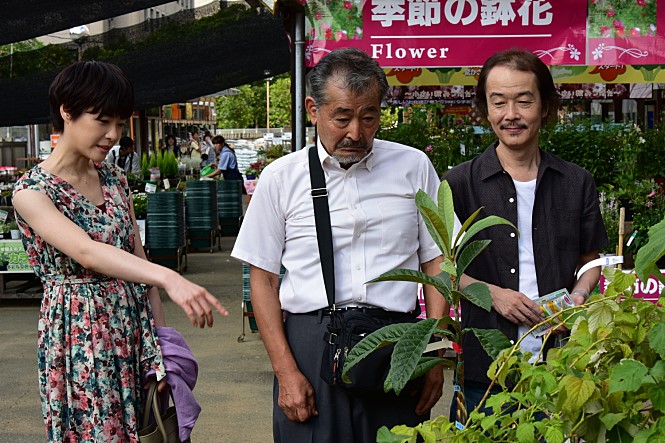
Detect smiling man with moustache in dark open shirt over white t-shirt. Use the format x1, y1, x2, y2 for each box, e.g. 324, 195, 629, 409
443, 49, 608, 420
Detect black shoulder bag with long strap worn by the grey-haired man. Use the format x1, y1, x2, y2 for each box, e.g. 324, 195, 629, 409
308, 146, 418, 395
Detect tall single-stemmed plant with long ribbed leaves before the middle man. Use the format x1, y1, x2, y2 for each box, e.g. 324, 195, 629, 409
342, 181, 516, 421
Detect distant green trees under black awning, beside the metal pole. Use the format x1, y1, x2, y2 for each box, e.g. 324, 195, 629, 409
215, 74, 291, 129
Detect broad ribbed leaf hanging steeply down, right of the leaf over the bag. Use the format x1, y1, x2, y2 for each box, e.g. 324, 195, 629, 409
388, 318, 439, 395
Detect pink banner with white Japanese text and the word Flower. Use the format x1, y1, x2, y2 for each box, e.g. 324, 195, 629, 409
299, 0, 665, 67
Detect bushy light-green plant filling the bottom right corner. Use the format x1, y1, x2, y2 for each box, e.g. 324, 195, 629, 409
377, 214, 665, 443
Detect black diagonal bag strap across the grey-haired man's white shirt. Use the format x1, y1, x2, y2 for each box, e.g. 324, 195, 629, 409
309, 145, 335, 309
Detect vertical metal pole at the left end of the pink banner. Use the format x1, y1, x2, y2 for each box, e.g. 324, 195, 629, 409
293, 10, 307, 150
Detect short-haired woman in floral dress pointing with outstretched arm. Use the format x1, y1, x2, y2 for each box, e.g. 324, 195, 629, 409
14, 62, 227, 442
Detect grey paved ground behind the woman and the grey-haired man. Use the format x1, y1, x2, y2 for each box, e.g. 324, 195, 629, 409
0, 237, 451, 443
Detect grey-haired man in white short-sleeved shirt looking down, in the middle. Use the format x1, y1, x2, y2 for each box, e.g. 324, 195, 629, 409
231, 48, 444, 443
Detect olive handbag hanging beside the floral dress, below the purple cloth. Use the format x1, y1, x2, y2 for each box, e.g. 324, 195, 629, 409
139, 380, 181, 443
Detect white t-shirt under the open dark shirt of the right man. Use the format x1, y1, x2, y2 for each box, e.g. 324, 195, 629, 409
513, 179, 543, 361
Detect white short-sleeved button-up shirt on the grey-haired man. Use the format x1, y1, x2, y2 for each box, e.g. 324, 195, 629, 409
231, 140, 441, 313
